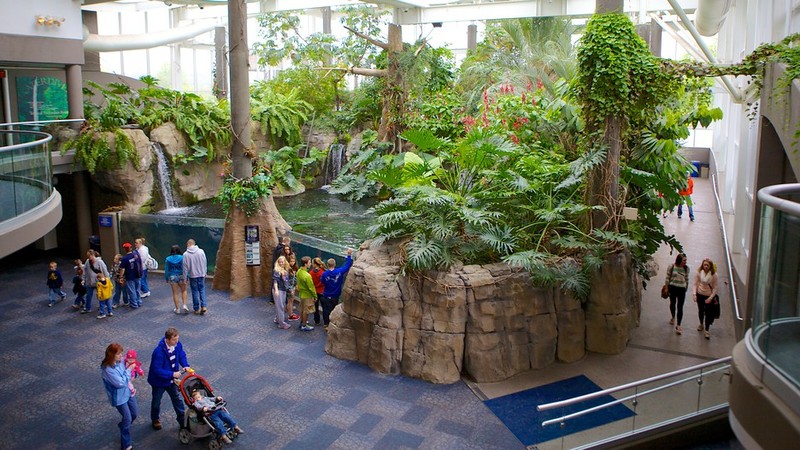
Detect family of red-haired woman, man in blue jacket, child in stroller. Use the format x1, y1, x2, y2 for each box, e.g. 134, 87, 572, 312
100, 327, 239, 450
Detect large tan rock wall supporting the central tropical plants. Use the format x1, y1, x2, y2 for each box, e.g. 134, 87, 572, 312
325, 245, 641, 383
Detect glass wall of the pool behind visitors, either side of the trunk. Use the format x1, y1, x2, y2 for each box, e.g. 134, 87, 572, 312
118, 213, 347, 273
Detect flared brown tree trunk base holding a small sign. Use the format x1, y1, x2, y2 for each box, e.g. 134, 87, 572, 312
213, 196, 291, 300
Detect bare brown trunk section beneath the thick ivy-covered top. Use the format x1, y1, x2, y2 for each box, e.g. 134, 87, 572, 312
589, 117, 622, 231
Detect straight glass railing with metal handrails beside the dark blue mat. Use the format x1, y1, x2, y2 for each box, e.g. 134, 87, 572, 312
531, 357, 731, 450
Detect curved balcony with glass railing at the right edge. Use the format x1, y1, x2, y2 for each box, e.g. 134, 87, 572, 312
730, 184, 800, 448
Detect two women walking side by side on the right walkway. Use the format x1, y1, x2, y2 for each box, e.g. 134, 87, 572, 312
664, 253, 720, 339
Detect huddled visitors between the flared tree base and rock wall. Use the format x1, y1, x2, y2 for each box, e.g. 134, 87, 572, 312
271, 236, 353, 331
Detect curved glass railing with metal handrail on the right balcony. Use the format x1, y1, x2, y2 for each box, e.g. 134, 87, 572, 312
748, 184, 800, 388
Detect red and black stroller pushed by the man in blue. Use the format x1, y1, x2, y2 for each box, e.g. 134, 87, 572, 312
178, 372, 238, 450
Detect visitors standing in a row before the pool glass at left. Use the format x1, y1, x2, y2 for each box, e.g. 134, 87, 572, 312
47, 237, 208, 319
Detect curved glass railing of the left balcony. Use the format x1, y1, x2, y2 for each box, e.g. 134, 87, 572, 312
0, 129, 53, 221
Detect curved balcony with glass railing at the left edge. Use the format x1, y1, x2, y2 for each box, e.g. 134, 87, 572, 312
0, 129, 62, 258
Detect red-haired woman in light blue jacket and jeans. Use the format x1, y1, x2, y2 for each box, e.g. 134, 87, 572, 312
100, 342, 139, 450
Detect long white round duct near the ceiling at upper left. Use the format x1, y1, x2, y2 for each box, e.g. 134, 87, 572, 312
83, 22, 219, 52
